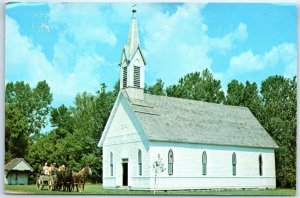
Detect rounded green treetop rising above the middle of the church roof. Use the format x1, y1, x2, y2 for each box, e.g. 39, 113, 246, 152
166, 69, 225, 103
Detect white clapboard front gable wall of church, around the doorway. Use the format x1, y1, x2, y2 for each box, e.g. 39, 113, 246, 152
103, 102, 150, 188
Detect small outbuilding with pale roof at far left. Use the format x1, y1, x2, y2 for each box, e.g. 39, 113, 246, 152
4, 158, 33, 184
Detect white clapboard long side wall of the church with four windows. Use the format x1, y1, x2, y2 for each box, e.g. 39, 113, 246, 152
149, 142, 276, 189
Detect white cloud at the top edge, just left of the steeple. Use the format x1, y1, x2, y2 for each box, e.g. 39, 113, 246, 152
49, 3, 117, 46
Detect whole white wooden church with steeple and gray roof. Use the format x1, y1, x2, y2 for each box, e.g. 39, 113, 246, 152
98, 7, 278, 190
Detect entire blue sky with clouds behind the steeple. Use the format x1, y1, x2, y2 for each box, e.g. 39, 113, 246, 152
5, 3, 297, 107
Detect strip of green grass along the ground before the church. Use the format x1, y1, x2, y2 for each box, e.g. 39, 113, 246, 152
5, 184, 296, 195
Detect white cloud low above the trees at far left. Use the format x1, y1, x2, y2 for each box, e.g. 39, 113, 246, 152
6, 16, 105, 105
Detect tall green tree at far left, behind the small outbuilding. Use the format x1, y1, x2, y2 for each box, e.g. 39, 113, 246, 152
5, 81, 52, 160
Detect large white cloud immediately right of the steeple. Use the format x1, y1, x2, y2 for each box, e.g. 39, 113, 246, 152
140, 4, 248, 85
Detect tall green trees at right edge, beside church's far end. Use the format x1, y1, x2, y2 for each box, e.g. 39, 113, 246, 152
260, 75, 297, 187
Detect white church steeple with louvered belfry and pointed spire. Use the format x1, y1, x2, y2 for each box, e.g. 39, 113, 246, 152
119, 6, 146, 100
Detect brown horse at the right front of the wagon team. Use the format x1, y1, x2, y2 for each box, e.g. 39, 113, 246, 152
72, 166, 92, 192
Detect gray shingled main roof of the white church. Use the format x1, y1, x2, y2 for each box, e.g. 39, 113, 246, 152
123, 92, 278, 148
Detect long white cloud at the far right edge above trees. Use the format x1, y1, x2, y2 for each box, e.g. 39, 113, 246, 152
228, 43, 297, 76
